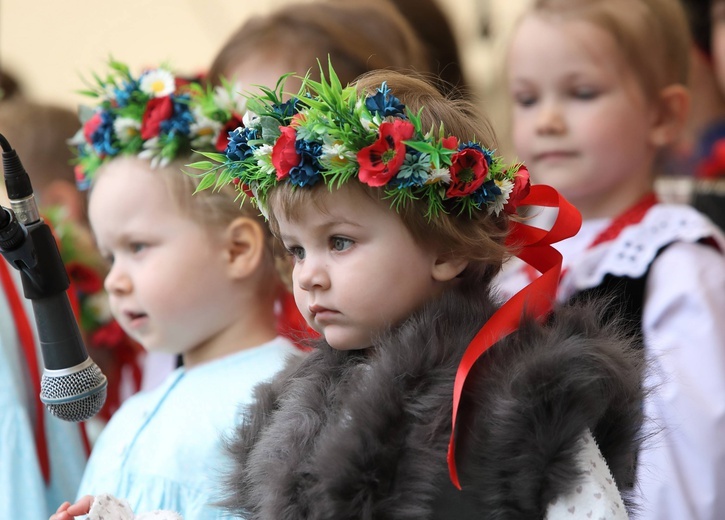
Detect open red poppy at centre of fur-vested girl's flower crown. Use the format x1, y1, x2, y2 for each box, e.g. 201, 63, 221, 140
357, 119, 415, 186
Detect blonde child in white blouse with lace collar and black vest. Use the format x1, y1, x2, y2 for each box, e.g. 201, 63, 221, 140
501, 0, 725, 520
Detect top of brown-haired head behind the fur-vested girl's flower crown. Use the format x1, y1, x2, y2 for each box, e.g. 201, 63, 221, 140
208, 0, 430, 96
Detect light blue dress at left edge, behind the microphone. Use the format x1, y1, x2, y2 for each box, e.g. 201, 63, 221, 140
0, 266, 86, 520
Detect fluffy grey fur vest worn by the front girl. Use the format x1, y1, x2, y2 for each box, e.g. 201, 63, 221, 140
225, 288, 642, 520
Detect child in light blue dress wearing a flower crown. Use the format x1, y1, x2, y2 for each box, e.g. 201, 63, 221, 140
51, 63, 295, 519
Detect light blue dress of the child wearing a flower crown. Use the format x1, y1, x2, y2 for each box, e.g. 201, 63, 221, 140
78, 338, 299, 520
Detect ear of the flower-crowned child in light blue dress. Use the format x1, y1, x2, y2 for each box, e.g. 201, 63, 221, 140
225, 217, 266, 279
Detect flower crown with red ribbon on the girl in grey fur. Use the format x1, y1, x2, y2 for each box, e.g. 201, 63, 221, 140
189, 65, 529, 218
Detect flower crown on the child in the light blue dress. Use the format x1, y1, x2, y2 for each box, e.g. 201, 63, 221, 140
70, 60, 244, 189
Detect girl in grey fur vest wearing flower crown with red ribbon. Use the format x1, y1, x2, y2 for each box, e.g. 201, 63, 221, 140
58, 63, 641, 520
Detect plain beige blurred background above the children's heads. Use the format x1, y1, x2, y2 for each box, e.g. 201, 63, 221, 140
0, 0, 528, 157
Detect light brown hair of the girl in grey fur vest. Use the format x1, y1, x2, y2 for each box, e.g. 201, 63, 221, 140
268, 70, 508, 284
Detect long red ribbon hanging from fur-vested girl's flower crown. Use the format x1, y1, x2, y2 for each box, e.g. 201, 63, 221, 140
448, 185, 582, 489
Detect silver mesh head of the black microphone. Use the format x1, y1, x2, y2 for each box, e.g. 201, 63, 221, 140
40, 358, 108, 422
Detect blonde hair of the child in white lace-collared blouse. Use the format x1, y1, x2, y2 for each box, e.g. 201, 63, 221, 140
526, 0, 690, 99
